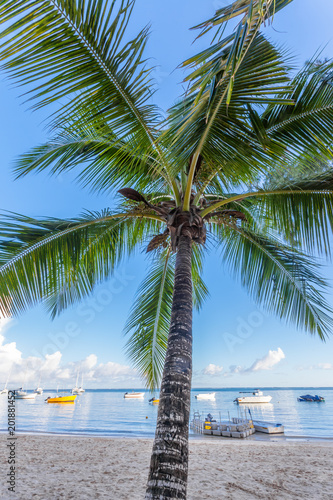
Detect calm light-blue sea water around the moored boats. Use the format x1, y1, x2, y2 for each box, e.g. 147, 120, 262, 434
0, 388, 333, 438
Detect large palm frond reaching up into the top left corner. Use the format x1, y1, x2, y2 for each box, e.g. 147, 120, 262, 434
0, 0, 178, 196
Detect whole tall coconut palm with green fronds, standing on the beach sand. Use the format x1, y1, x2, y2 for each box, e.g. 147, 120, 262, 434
0, 0, 333, 499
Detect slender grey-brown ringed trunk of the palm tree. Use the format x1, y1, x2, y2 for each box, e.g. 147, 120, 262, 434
146, 235, 192, 500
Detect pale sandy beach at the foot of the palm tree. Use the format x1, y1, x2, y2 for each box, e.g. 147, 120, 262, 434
0, 434, 333, 500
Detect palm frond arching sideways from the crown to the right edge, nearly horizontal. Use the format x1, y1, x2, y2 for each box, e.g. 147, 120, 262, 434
202, 169, 333, 255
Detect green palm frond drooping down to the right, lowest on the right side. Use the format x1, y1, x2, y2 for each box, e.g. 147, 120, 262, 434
213, 223, 333, 340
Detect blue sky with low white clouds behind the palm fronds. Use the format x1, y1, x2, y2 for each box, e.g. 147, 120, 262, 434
0, 0, 333, 388
